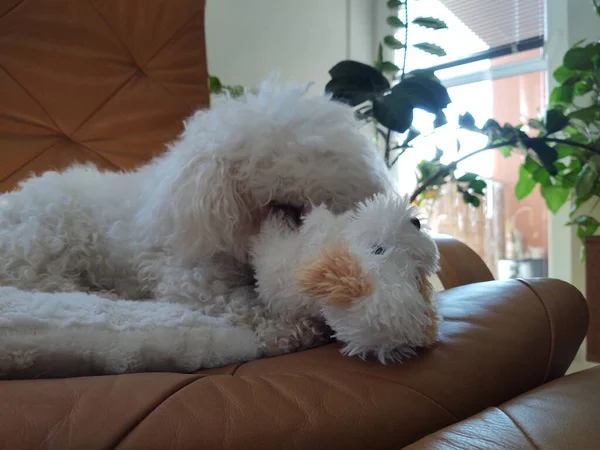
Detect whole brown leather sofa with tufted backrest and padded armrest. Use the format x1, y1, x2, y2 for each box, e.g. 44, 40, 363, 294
0, 0, 600, 450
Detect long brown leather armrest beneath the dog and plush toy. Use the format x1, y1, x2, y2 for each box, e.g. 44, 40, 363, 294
0, 280, 587, 450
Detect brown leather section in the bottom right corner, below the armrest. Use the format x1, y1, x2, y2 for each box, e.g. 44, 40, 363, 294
406, 367, 600, 450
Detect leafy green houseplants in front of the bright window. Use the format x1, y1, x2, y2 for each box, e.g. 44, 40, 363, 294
327, 0, 600, 250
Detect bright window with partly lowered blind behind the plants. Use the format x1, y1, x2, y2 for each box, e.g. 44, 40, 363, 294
395, 0, 548, 279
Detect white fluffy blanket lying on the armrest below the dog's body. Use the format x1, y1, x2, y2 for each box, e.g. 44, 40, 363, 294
0, 287, 259, 378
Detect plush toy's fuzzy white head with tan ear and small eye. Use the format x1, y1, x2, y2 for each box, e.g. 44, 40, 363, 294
297, 195, 439, 362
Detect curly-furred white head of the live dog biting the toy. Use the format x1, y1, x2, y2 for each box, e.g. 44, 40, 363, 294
137, 79, 390, 261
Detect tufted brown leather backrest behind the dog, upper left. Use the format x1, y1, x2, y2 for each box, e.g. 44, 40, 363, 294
0, 0, 208, 191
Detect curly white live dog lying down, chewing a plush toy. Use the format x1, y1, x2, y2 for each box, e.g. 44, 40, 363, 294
0, 83, 390, 356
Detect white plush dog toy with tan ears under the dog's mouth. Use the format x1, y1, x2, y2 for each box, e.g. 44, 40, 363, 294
251, 195, 439, 362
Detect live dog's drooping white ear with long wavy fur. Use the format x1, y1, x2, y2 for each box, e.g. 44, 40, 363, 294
136, 149, 251, 261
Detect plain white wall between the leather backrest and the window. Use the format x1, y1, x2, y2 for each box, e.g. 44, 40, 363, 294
206, 0, 375, 93
